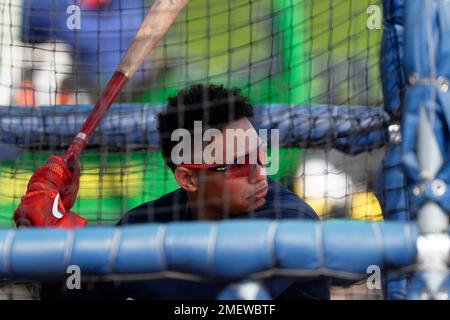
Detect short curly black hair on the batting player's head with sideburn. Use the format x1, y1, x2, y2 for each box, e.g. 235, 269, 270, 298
158, 84, 254, 171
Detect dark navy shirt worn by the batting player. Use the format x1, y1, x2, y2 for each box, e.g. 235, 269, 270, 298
41, 179, 330, 299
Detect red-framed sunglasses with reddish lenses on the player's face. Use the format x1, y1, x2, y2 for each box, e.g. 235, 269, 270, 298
181, 144, 267, 178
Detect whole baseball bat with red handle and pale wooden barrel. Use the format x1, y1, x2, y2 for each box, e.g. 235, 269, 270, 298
64, 0, 189, 162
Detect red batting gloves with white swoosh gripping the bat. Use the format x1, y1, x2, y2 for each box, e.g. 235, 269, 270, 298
14, 156, 88, 229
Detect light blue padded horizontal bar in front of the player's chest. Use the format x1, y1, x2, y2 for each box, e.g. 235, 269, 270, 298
0, 219, 418, 280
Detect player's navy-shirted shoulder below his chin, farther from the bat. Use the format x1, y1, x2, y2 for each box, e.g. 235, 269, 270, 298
264, 178, 319, 220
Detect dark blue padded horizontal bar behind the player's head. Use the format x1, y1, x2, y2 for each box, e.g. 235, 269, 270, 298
0, 104, 390, 154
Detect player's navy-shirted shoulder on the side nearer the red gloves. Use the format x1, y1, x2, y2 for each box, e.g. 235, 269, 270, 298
117, 189, 188, 225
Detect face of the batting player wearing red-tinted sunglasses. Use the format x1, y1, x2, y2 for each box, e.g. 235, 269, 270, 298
190, 118, 268, 217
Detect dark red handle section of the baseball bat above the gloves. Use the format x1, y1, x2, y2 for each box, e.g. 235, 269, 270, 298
64, 71, 128, 162
